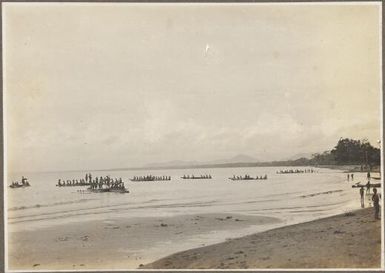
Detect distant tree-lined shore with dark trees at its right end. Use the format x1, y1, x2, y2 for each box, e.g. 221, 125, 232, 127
99, 138, 381, 171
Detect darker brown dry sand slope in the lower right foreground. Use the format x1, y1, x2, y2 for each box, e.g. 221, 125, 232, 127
142, 208, 381, 269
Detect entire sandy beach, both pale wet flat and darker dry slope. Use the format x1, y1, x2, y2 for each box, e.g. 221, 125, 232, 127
9, 208, 381, 270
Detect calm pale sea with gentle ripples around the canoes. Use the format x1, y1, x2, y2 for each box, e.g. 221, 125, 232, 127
7, 167, 366, 232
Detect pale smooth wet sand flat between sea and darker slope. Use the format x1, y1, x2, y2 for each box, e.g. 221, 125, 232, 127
8, 210, 282, 270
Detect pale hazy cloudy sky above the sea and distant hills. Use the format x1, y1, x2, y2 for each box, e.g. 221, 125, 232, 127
2, 3, 381, 171
